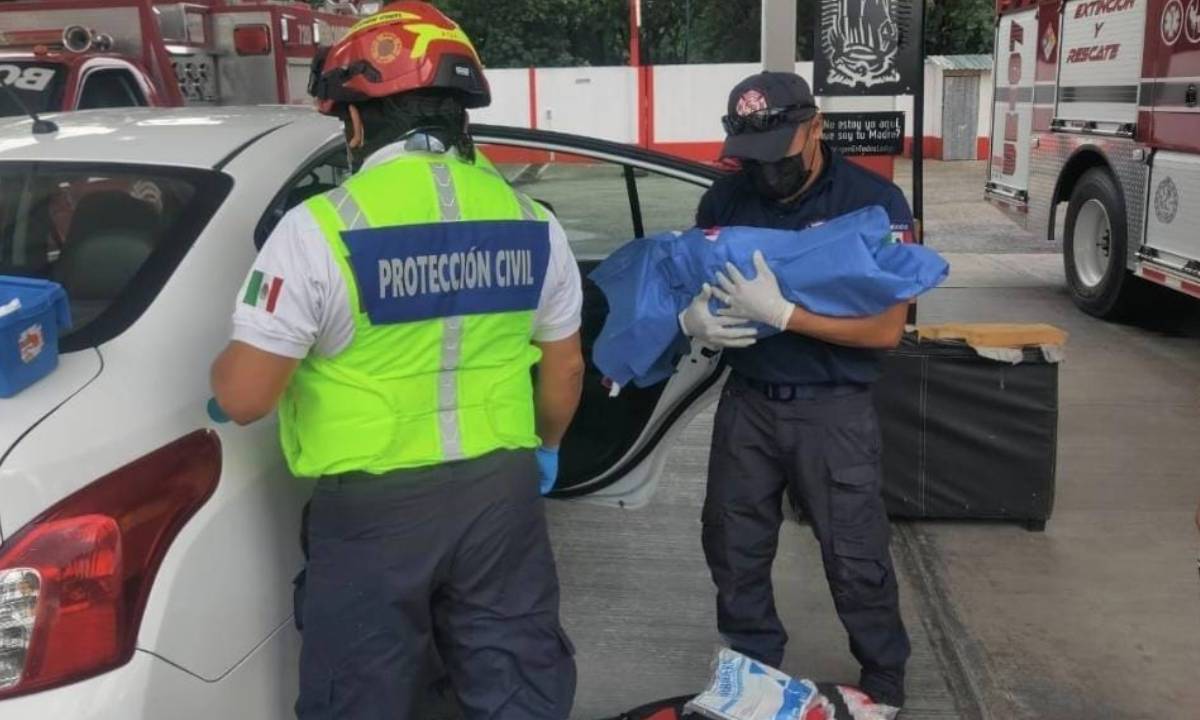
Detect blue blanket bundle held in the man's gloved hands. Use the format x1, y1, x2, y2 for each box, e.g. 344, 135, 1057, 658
589, 206, 949, 388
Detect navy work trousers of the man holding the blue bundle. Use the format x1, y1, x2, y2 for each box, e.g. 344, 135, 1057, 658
703, 376, 910, 707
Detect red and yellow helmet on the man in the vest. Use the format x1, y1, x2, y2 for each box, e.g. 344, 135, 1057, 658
308, 2, 492, 115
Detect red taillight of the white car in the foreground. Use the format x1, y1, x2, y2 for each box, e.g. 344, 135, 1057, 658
0, 431, 221, 698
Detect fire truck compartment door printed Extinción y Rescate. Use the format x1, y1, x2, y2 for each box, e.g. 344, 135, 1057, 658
1056, 0, 1150, 125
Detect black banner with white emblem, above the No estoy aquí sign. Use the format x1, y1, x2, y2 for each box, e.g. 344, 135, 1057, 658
812, 0, 922, 95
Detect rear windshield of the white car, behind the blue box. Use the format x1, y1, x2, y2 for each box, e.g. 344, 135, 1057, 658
0, 163, 230, 352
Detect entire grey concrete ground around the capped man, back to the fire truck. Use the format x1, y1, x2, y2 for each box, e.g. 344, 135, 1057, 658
551, 163, 1200, 720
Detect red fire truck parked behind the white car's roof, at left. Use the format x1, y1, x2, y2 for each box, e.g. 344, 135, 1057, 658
0, 0, 356, 116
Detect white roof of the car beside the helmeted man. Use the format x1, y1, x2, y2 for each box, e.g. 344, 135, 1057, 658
0, 106, 338, 168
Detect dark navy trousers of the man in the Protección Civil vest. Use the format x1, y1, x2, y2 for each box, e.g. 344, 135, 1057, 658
296, 451, 575, 720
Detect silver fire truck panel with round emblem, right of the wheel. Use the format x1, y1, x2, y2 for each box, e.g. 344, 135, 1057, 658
1146, 151, 1200, 265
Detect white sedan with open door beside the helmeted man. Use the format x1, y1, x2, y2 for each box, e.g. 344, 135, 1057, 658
0, 108, 721, 720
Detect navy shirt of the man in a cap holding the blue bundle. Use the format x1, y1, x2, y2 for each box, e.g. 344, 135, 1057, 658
696, 144, 912, 385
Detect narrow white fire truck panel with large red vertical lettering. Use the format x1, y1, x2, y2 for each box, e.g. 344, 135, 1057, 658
988, 7, 1038, 199
